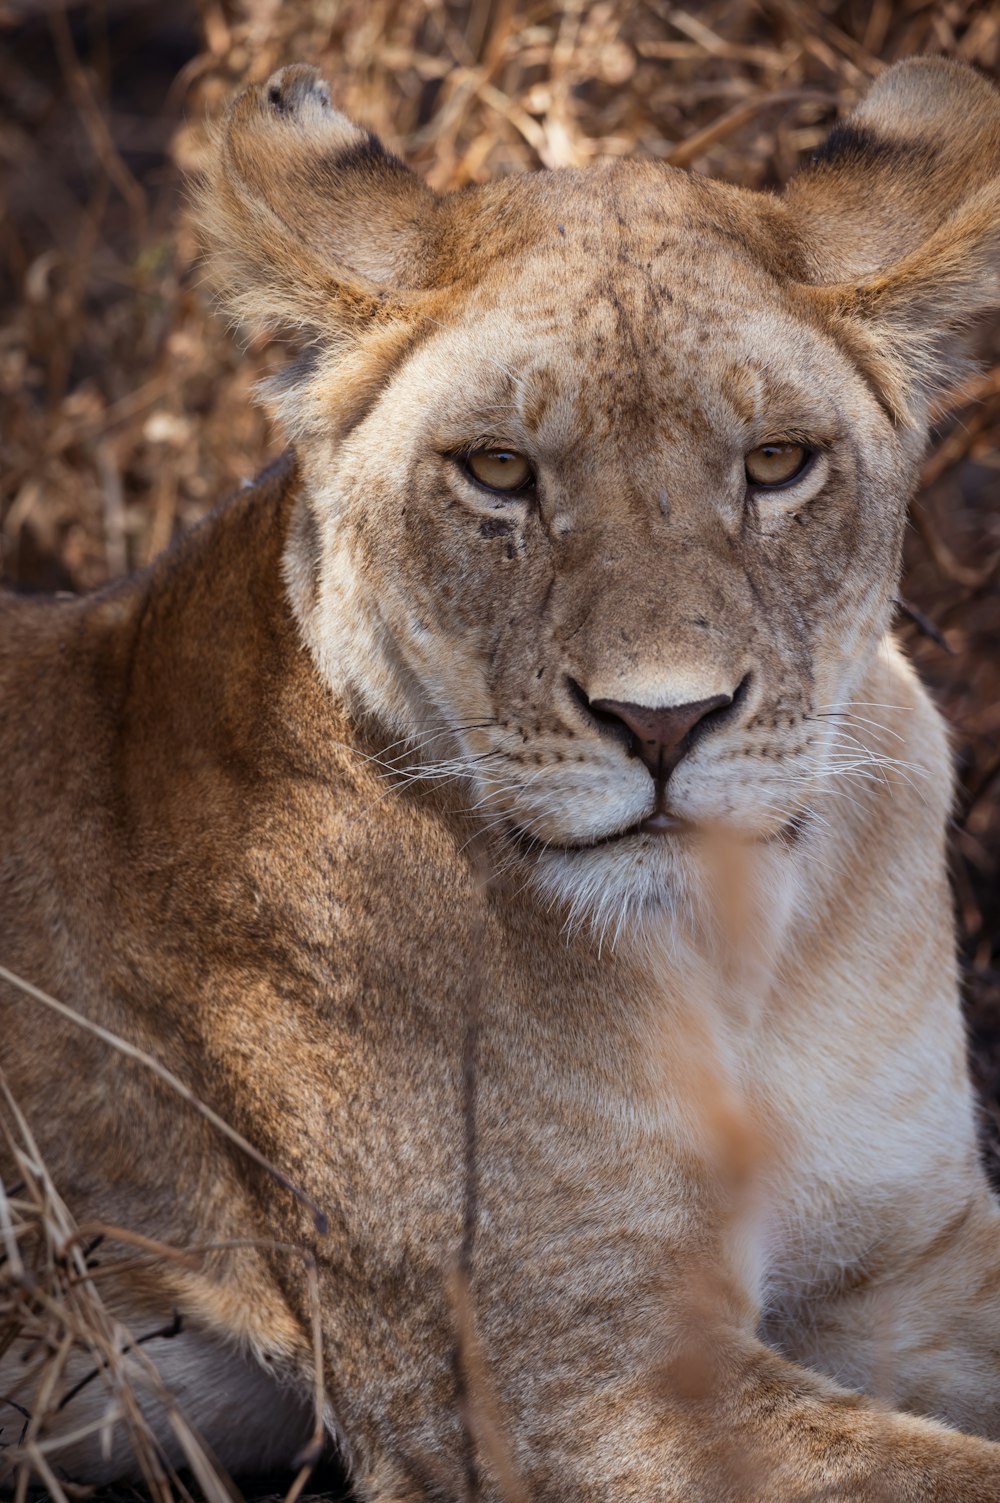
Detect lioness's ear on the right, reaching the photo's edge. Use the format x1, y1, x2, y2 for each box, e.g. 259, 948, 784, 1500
785, 57, 1000, 424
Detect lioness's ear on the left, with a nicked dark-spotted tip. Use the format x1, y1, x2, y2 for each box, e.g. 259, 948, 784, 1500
195, 63, 439, 340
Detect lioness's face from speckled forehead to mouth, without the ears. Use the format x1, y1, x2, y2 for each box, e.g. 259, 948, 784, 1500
300, 167, 908, 883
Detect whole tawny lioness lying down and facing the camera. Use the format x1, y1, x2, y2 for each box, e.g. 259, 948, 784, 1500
0, 60, 1000, 1503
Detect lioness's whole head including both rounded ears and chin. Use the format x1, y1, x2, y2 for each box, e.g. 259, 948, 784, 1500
202, 60, 1000, 937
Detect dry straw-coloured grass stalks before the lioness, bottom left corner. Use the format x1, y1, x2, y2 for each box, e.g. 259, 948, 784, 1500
0, 966, 326, 1503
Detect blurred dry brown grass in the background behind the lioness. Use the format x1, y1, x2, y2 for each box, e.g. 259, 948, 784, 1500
0, 0, 1000, 1496
